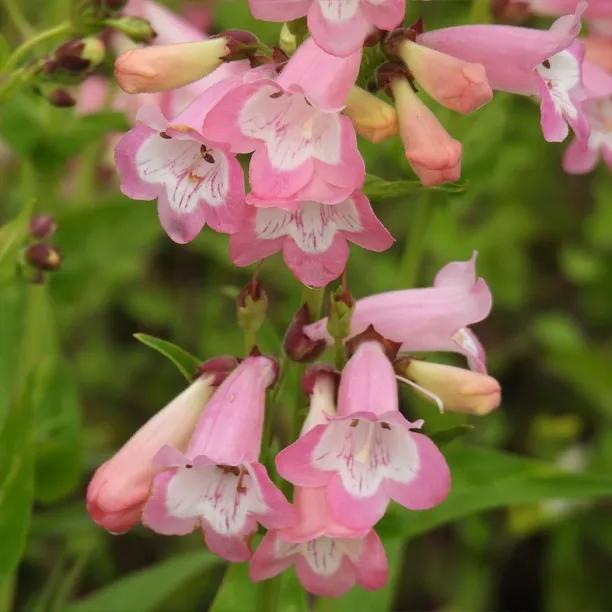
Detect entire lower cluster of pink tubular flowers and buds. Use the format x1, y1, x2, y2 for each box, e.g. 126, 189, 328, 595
87, 259, 500, 596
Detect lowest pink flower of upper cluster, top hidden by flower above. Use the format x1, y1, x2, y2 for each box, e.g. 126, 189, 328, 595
230, 191, 393, 287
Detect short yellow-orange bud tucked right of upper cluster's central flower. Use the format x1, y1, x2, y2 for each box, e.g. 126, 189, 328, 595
344, 87, 398, 143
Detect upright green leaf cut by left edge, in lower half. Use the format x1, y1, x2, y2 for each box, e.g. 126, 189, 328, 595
0, 368, 36, 583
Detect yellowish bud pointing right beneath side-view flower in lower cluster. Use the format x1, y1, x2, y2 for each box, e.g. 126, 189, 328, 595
402, 359, 501, 416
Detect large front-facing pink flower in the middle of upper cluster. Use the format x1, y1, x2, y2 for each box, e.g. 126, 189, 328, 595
204, 40, 365, 206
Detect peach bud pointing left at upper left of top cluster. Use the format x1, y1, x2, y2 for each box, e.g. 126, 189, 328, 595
115, 37, 229, 94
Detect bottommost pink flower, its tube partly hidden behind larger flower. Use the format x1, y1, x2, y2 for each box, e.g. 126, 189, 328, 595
249, 370, 388, 597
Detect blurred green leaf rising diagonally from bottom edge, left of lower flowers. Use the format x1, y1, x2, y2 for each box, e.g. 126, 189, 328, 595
64, 550, 221, 612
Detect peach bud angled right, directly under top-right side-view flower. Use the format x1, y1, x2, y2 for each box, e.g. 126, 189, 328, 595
398, 40, 493, 114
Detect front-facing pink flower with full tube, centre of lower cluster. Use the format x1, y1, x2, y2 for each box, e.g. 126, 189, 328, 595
276, 341, 450, 530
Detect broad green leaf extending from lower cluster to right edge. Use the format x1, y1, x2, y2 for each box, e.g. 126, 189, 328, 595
380, 448, 612, 538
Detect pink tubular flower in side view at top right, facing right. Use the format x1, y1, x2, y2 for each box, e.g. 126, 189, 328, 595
417, 2, 588, 142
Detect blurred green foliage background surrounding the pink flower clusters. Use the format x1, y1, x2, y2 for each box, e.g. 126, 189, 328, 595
0, 0, 612, 612
